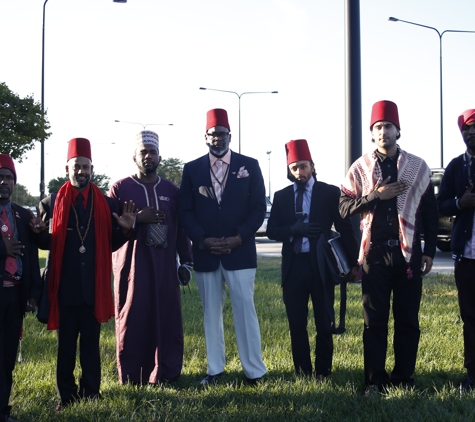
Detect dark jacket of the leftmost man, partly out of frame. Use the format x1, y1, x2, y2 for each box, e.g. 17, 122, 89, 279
0, 203, 41, 308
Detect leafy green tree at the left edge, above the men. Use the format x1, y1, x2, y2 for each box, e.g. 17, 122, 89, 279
0, 82, 51, 163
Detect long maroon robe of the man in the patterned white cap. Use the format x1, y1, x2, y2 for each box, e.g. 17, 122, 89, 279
109, 176, 193, 384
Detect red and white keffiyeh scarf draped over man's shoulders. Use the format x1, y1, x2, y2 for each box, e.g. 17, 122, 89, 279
341, 147, 431, 275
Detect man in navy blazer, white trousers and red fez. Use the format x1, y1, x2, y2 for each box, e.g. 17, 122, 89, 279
178, 108, 266, 386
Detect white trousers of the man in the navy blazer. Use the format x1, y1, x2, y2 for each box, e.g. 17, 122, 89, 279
195, 264, 266, 379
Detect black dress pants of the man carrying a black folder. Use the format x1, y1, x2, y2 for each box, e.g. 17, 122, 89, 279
283, 253, 333, 376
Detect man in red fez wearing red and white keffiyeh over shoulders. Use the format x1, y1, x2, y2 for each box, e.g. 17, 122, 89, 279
340, 101, 438, 395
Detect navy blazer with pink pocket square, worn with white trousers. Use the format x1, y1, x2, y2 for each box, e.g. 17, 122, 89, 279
178, 152, 266, 272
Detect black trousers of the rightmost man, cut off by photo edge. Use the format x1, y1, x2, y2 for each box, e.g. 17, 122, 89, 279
454, 258, 475, 378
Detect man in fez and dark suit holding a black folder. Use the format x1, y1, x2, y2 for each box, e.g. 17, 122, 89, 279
267, 139, 358, 381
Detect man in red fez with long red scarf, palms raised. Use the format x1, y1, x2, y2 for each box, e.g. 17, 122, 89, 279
33, 138, 135, 411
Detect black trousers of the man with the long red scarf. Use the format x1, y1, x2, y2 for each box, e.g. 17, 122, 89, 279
56, 305, 101, 405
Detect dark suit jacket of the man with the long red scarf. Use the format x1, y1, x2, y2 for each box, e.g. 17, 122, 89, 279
39, 190, 127, 306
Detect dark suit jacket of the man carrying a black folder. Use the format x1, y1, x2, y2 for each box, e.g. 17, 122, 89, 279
267, 181, 358, 285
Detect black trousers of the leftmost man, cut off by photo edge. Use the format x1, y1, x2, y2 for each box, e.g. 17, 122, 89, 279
0, 285, 24, 418
